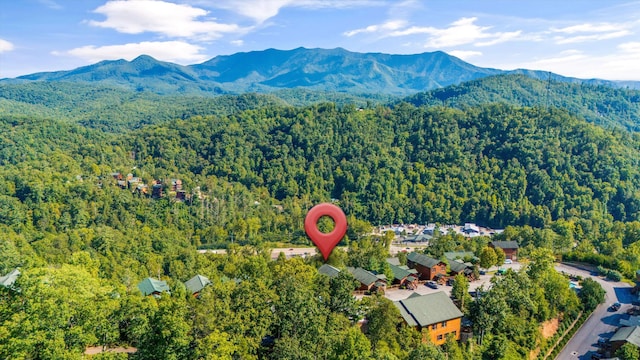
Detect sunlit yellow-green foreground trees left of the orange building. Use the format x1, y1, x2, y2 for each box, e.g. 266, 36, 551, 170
0, 247, 460, 359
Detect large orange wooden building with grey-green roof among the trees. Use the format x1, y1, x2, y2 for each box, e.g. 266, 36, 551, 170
394, 291, 463, 345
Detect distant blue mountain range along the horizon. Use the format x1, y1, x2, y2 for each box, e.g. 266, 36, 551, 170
5, 48, 640, 96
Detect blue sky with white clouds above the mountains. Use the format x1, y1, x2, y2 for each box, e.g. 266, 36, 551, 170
0, 0, 640, 80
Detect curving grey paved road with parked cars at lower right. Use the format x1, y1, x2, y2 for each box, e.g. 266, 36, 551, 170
556, 264, 632, 360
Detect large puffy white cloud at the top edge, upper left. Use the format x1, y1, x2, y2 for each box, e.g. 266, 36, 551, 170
89, 0, 246, 40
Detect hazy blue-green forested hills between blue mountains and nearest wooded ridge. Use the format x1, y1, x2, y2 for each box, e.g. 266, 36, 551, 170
0, 74, 640, 132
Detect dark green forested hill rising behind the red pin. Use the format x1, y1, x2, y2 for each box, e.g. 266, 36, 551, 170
125, 100, 640, 227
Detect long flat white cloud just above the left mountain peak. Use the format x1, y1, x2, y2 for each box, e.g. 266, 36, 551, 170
53, 41, 207, 64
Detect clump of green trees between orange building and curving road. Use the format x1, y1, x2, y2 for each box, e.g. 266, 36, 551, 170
469, 249, 582, 359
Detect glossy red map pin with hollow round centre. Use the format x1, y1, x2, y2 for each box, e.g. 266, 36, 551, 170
304, 203, 347, 261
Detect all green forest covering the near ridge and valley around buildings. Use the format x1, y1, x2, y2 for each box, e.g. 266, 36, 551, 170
0, 92, 640, 359
